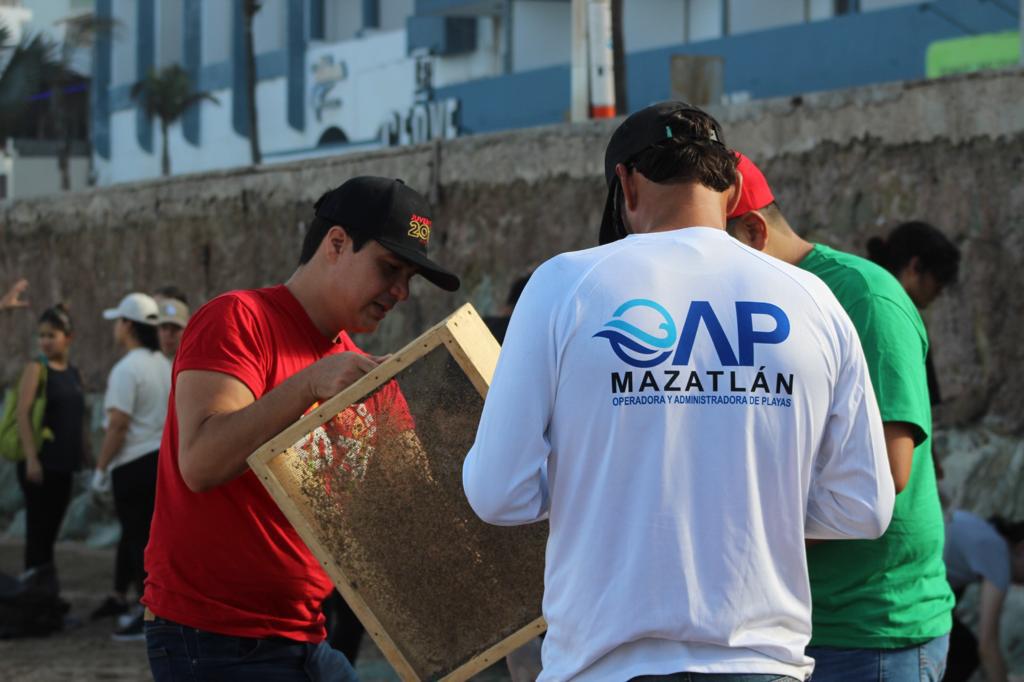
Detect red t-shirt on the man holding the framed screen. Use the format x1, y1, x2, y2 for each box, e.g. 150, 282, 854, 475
142, 286, 412, 642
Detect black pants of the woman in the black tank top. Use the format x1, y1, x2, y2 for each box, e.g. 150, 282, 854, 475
17, 462, 72, 570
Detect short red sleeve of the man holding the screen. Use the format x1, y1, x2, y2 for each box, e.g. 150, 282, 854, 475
174, 294, 273, 398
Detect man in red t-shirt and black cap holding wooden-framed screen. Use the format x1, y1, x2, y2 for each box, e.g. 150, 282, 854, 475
142, 177, 459, 682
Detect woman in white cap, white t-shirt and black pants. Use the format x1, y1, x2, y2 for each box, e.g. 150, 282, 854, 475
92, 293, 171, 639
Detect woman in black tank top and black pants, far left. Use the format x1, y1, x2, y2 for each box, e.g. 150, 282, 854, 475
17, 305, 86, 581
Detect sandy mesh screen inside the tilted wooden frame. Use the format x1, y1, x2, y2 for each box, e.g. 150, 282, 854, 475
271, 346, 547, 679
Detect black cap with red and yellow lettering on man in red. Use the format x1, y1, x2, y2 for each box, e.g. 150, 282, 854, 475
313, 175, 460, 291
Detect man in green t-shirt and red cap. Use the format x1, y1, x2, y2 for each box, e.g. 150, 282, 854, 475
727, 155, 953, 682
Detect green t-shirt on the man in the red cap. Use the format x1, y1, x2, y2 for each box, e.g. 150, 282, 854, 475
800, 245, 953, 649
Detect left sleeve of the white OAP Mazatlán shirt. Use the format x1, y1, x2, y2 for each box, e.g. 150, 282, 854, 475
462, 263, 565, 525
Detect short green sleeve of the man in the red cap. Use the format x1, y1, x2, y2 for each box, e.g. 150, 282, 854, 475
849, 296, 932, 445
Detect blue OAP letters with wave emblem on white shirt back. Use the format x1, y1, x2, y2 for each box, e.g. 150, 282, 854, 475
594, 298, 790, 368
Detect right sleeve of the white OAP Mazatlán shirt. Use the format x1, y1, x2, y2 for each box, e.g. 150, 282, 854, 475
805, 315, 896, 540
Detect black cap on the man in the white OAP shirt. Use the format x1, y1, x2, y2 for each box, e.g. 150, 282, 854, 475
598, 101, 725, 244
